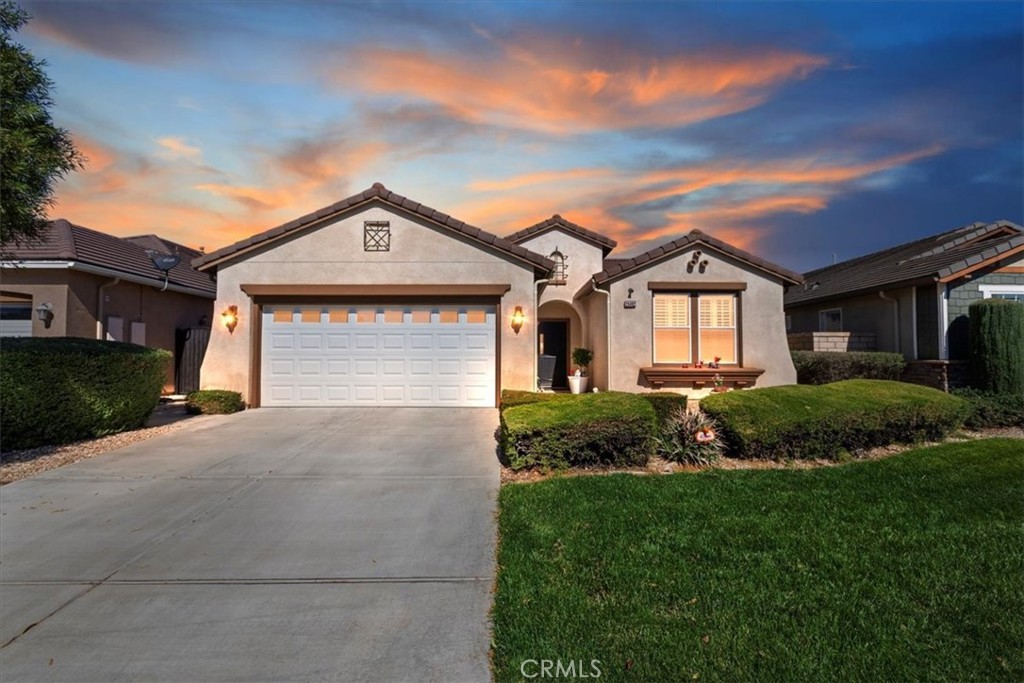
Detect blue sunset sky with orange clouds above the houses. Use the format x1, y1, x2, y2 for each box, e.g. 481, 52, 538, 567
17, 2, 1024, 271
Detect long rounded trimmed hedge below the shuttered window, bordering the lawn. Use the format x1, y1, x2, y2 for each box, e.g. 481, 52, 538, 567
700, 380, 971, 460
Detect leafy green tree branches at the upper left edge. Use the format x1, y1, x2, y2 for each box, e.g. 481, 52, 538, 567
0, 0, 84, 247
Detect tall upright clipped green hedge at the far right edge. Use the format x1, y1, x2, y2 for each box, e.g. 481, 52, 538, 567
968, 299, 1024, 395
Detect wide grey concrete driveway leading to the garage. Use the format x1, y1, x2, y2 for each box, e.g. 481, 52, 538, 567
0, 409, 499, 683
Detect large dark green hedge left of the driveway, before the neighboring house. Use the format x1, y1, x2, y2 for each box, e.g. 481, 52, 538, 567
0, 337, 171, 451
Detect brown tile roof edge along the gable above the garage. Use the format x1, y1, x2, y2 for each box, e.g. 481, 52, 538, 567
193, 187, 554, 272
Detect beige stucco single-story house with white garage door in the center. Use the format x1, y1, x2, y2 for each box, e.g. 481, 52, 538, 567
194, 183, 801, 407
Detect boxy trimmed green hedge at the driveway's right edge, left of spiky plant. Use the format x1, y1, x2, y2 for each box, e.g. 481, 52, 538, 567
501, 391, 657, 469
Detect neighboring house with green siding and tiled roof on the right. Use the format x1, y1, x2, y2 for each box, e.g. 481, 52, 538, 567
785, 221, 1024, 360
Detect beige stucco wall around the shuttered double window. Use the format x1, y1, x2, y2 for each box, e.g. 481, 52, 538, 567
589, 245, 797, 391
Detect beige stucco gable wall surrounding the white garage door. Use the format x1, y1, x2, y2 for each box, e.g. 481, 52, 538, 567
195, 205, 537, 399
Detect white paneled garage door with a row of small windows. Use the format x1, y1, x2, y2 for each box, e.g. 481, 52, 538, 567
261, 304, 496, 408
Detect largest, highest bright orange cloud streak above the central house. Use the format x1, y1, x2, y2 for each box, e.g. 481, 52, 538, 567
327, 46, 827, 133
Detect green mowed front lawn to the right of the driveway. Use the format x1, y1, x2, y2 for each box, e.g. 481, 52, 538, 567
494, 439, 1024, 681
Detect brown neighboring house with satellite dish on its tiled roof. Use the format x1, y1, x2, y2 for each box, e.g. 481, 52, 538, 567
0, 220, 217, 391
